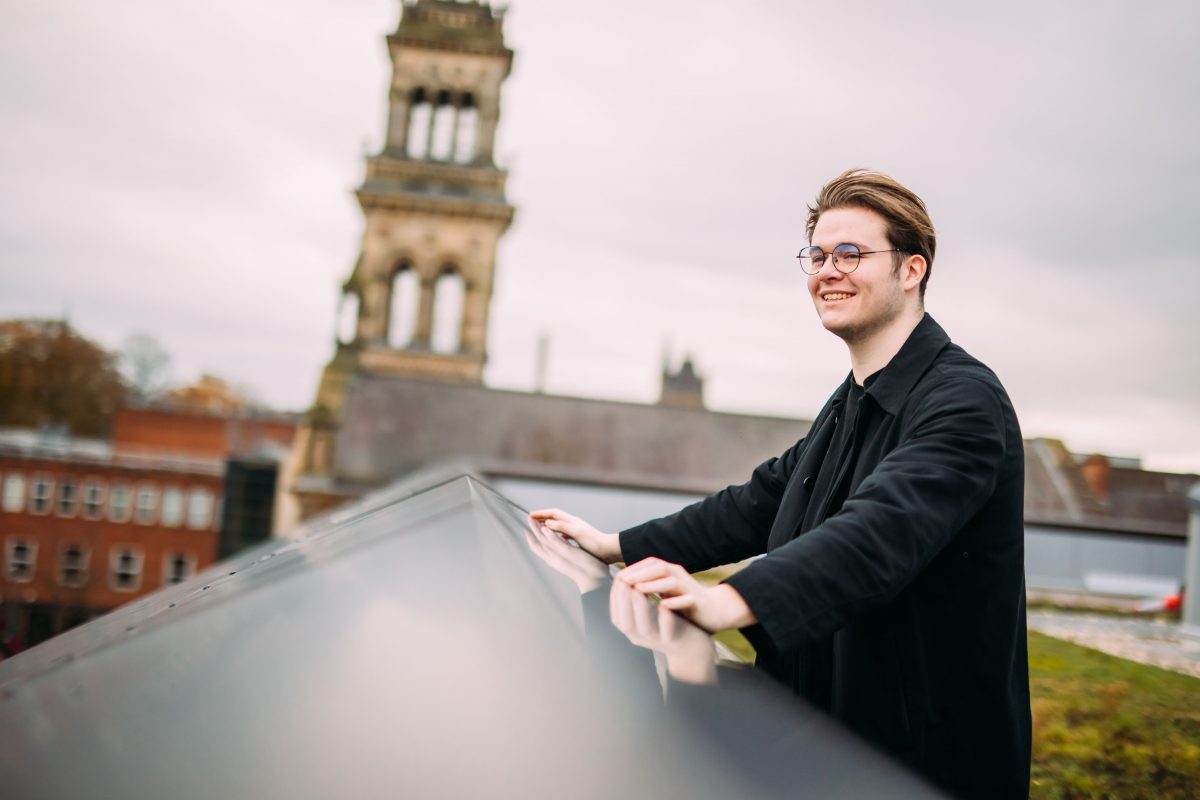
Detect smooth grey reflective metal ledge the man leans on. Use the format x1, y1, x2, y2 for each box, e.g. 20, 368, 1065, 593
0, 476, 935, 799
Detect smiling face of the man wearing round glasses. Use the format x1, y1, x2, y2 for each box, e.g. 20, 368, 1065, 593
809, 209, 906, 344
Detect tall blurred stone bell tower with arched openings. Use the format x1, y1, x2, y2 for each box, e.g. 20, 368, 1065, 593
293, 0, 512, 517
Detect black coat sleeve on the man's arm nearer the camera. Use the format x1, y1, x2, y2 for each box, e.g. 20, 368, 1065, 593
726, 377, 1008, 651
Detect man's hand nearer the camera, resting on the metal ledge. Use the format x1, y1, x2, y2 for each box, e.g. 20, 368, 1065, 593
617, 558, 758, 633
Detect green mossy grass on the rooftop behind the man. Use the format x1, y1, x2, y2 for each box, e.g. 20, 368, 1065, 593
700, 631, 1200, 800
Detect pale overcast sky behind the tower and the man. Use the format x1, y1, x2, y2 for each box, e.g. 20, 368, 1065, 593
0, 0, 1200, 471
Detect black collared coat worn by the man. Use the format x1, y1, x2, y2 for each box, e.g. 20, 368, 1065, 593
620, 314, 1030, 798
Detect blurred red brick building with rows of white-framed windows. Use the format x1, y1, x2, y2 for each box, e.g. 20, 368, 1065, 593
0, 408, 294, 655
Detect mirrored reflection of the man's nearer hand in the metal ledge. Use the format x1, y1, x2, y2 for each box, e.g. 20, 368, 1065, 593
608, 581, 716, 684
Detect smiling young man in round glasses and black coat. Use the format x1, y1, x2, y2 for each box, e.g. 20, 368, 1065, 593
533, 169, 1030, 798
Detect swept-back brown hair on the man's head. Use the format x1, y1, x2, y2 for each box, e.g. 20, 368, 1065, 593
805, 167, 937, 299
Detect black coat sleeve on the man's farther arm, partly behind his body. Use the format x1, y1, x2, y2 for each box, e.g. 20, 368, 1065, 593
620, 439, 804, 572
